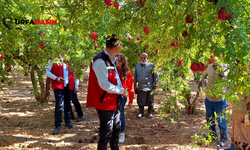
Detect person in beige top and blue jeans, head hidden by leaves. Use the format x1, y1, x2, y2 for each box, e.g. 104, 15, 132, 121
201, 55, 229, 146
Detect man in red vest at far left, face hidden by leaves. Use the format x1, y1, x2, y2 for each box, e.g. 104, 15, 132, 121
46, 55, 75, 134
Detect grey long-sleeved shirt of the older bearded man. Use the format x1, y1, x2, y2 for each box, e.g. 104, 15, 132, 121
134, 62, 158, 91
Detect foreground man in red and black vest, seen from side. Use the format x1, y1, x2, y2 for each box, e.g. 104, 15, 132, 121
86, 34, 128, 150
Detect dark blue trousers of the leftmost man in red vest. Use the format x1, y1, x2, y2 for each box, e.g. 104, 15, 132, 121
54, 87, 70, 127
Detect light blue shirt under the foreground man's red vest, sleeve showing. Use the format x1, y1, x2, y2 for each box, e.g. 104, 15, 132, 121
92, 50, 124, 94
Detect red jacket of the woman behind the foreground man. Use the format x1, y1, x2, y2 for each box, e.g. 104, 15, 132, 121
118, 70, 135, 104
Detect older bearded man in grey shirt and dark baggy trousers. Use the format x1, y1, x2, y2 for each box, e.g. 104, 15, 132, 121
134, 53, 158, 118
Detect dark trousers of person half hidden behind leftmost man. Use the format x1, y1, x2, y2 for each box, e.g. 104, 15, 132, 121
70, 90, 83, 118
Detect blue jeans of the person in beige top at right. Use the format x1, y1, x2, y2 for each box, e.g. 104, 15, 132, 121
205, 98, 227, 139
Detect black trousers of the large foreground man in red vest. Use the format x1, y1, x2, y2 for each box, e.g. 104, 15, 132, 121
96, 95, 121, 150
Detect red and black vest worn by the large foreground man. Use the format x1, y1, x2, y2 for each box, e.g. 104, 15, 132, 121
86, 52, 117, 110
